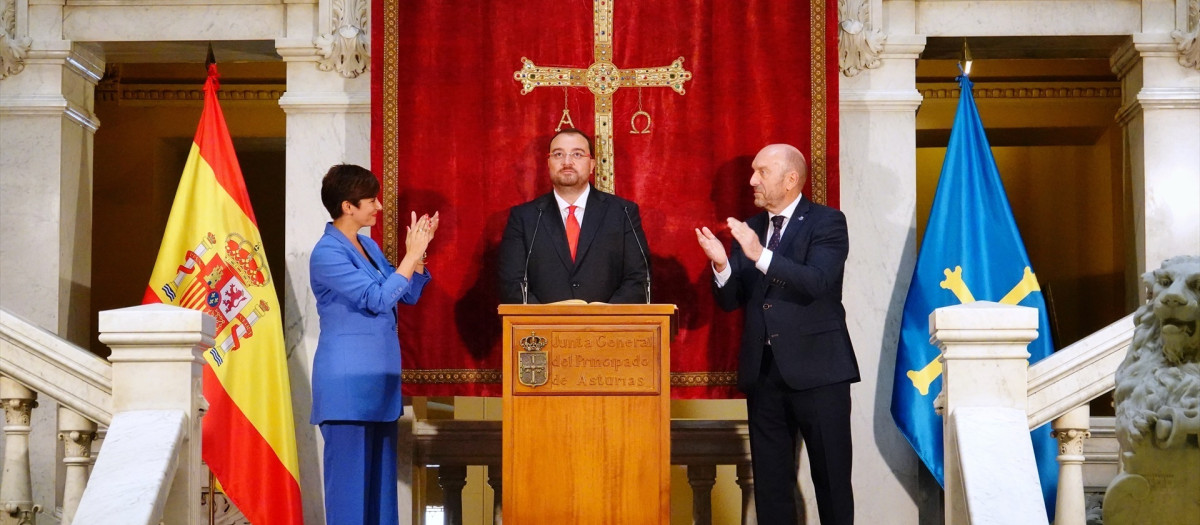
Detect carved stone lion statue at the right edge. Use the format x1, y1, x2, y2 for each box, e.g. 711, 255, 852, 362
1104, 255, 1200, 525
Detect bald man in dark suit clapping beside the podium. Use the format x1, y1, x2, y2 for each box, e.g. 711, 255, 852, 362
696, 144, 859, 525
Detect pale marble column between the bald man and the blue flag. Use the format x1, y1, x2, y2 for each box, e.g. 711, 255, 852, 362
840, 35, 921, 523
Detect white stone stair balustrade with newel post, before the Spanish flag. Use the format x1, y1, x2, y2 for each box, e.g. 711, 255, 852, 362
0, 304, 208, 525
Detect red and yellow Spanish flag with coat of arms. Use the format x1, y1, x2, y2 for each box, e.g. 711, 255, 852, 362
142, 64, 304, 525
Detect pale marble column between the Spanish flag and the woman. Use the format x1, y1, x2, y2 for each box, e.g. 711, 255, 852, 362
276, 34, 369, 524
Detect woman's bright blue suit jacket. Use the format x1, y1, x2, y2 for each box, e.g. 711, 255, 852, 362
308, 223, 430, 424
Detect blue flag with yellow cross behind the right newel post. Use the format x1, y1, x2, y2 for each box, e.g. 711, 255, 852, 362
892, 76, 1058, 519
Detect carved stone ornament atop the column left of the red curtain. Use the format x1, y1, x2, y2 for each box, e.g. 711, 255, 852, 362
313, 0, 371, 78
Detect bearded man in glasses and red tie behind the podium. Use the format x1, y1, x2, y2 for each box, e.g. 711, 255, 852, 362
499, 128, 650, 304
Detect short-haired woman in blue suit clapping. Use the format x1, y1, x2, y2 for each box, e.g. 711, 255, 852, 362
308, 164, 438, 525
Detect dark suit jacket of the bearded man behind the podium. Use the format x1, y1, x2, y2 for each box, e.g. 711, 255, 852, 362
499, 187, 650, 304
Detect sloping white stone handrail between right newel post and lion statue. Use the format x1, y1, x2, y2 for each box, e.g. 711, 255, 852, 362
1026, 314, 1134, 429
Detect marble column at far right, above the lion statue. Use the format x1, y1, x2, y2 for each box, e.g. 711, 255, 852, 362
1111, 32, 1200, 299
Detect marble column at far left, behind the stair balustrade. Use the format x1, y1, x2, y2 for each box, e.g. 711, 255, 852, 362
0, 33, 104, 520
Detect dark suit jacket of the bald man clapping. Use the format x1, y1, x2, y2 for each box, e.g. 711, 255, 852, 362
713, 198, 858, 392
